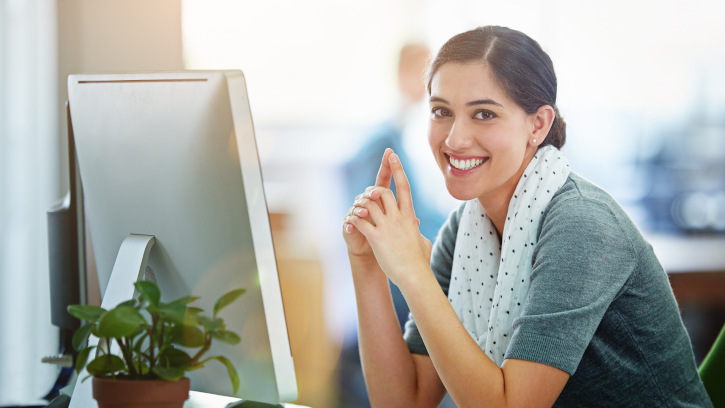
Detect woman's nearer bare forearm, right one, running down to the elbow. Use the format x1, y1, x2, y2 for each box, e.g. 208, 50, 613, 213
401, 273, 506, 407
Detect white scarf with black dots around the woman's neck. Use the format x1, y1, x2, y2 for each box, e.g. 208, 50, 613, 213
448, 146, 569, 367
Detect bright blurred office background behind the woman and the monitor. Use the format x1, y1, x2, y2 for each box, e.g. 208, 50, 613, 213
0, 0, 725, 407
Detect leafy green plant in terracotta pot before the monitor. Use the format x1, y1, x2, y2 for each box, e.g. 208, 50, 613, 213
68, 281, 245, 408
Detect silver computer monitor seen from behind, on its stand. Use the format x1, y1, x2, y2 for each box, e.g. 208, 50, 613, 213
68, 71, 297, 407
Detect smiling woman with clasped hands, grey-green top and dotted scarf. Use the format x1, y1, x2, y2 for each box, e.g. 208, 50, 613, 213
343, 27, 711, 407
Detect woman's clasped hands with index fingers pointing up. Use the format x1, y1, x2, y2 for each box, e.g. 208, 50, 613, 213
343, 149, 431, 286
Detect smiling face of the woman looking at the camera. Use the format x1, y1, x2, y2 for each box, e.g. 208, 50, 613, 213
428, 62, 540, 205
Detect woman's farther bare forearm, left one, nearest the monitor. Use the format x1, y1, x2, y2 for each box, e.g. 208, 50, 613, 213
350, 253, 428, 407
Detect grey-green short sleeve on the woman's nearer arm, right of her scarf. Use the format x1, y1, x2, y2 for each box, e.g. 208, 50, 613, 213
506, 195, 636, 374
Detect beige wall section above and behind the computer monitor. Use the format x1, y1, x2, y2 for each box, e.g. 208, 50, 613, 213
58, 0, 184, 304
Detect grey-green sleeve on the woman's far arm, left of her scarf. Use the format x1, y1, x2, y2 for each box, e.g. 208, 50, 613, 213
403, 203, 465, 355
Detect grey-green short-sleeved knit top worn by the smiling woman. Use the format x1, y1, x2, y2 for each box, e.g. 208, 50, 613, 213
405, 172, 712, 408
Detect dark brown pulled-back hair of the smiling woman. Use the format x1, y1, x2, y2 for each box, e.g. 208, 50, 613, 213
428, 26, 566, 149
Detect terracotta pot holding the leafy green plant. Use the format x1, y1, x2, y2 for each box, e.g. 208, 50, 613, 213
93, 377, 190, 408
